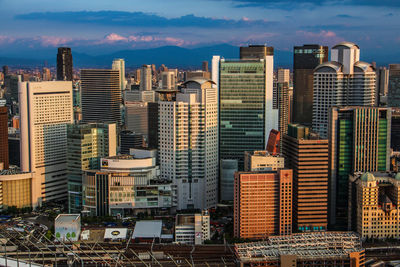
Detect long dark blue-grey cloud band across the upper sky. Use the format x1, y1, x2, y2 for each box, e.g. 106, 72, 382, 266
15, 11, 273, 28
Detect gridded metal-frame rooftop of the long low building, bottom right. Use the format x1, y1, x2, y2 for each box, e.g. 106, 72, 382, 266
235, 232, 363, 262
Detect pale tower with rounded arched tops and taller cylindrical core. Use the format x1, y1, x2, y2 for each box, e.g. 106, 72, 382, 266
313, 42, 376, 138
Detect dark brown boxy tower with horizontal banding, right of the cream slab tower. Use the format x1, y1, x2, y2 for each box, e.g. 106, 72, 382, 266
81, 69, 121, 124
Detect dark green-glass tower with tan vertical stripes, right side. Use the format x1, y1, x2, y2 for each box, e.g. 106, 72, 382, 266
328, 107, 392, 229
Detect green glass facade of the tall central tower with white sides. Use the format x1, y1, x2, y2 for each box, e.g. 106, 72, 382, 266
219, 60, 266, 170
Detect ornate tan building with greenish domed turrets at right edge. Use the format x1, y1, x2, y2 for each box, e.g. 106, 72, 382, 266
349, 172, 400, 239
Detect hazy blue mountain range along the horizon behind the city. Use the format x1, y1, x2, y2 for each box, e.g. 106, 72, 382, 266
0, 44, 292, 68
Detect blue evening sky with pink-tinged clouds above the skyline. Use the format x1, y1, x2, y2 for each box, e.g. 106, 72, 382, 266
0, 0, 400, 61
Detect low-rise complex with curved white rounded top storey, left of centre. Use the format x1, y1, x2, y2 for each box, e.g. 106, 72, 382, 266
83, 149, 173, 216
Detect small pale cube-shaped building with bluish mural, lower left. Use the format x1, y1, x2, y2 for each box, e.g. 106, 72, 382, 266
54, 214, 81, 242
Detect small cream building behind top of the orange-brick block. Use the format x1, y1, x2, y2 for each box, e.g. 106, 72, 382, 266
244, 150, 285, 172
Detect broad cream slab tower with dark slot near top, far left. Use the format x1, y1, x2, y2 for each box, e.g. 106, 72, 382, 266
18, 81, 73, 206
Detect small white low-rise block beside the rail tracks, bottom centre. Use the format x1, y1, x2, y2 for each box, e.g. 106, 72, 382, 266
175, 211, 210, 245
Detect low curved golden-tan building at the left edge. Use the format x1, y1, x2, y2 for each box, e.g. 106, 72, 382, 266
0, 168, 34, 211
